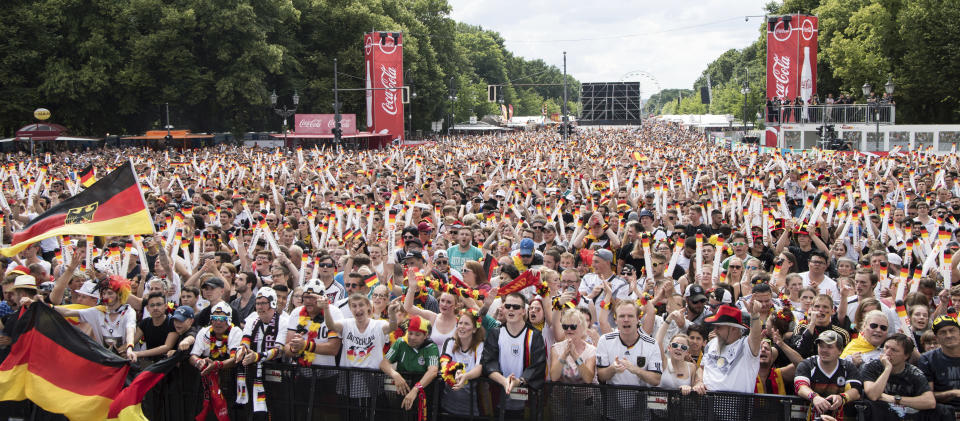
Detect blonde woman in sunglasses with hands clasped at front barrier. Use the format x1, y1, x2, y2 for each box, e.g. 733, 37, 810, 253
550, 308, 597, 384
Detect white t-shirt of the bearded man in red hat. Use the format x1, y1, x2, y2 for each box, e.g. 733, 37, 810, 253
700, 335, 760, 393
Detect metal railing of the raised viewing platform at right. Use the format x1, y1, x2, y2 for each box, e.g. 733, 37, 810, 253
764, 104, 896, 125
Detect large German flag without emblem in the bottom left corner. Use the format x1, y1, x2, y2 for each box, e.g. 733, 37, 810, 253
0, 302, 129, 420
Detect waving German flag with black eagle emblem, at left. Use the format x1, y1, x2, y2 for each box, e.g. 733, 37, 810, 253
0, 160, 153, 257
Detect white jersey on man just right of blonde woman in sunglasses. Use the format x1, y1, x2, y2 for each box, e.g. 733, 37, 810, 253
597, 332, 663, 386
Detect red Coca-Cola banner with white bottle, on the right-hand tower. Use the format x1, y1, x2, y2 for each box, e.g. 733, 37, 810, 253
766, 14, 818, 146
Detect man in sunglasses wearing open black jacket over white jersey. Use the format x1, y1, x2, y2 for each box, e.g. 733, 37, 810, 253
480, 292, 547, 419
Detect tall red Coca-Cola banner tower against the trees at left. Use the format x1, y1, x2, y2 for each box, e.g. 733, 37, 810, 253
363, 32, 403, 139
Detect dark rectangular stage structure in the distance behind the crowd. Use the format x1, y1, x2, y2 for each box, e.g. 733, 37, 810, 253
577, 82, 643, 125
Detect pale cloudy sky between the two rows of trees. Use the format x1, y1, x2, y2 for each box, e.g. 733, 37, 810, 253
449, 0, 765, 98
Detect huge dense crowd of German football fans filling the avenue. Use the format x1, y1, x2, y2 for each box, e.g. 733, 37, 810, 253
0, 120, 960, 420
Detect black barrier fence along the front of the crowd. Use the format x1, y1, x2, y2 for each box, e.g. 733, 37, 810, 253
0, 363, 808, 421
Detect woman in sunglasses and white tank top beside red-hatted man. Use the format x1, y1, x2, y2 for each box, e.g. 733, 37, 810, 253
657, 310, 697, 395
